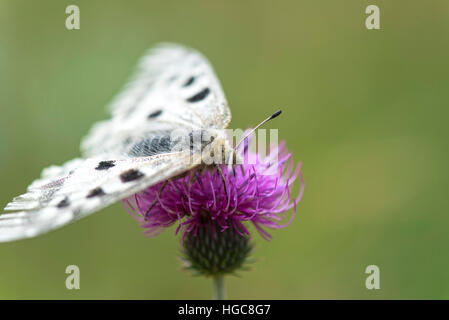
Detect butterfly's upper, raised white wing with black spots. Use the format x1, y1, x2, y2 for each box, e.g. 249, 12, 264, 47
81, 44, 231, 156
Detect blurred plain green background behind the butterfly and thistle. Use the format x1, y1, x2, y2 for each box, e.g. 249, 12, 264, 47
0, 0, 449, 299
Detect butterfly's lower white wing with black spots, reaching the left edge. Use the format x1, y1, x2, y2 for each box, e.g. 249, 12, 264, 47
0, 151, 194, 242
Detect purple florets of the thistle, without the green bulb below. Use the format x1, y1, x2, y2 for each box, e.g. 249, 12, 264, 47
123, 142, 304, 240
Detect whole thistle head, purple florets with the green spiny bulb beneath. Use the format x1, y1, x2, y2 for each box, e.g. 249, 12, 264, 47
123, 139, 304, 275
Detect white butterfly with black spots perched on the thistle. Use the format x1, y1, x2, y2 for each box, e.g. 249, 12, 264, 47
0, 44, 242, 242
